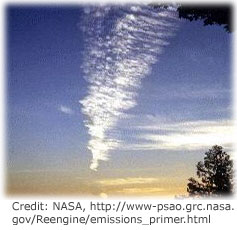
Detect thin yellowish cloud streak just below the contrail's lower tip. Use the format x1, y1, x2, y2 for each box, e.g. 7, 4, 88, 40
97, 177, 159, 186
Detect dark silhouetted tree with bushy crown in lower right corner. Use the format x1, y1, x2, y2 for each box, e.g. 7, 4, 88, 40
187, 145, 233, 196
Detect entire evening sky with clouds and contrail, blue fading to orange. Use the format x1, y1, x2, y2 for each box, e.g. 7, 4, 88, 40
6, 5, 233, 197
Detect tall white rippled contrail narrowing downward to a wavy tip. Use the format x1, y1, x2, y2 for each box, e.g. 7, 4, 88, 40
80, 5, 177, 170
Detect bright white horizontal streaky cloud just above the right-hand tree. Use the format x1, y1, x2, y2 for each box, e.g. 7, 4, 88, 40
120, 120, 234, 151
